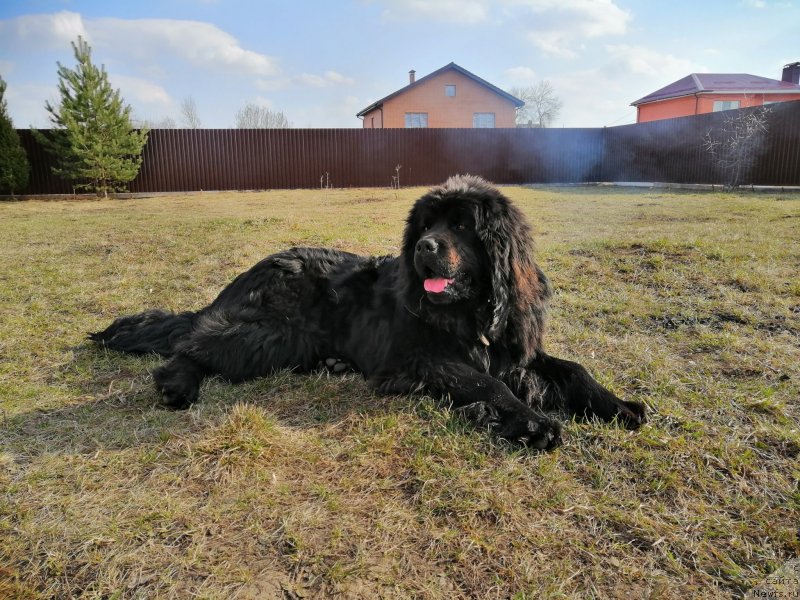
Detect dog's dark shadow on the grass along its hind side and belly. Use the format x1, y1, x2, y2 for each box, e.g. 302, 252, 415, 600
0, 344, 415, 459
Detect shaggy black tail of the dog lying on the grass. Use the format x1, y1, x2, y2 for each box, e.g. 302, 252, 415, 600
89, 310, 198, 356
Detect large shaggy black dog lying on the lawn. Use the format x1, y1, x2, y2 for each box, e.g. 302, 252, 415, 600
90, 176, 645, 448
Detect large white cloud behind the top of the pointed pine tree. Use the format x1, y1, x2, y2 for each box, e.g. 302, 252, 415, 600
0, 11, 280, 125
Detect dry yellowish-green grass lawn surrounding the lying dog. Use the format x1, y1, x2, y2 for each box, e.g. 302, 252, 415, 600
0, 187, 800, 600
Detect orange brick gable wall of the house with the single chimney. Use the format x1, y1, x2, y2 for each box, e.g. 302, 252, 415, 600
363, 70, 516, 129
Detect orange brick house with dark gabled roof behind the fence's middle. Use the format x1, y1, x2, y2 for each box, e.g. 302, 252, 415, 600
356, 63, 525, 129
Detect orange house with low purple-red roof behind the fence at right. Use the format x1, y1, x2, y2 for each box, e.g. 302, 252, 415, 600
631, 62, 800, 123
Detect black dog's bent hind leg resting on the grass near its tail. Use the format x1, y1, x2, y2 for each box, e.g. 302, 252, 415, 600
153, 311, 325, 408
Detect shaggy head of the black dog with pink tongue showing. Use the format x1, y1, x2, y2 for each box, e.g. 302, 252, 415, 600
403, 175, 550, 360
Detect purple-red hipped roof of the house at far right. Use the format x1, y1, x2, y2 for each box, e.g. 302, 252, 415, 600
631, 73, 800, 106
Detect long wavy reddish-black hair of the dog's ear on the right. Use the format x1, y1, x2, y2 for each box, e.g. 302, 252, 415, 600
475, 182, 551, 363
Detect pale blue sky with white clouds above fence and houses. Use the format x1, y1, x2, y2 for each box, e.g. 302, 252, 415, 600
0, 0, 800, 127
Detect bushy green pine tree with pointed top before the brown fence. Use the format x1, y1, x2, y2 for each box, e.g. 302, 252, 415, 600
35, 36, 147, 196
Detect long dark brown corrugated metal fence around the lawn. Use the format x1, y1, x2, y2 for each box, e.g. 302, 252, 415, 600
12, 102, 800, 194
